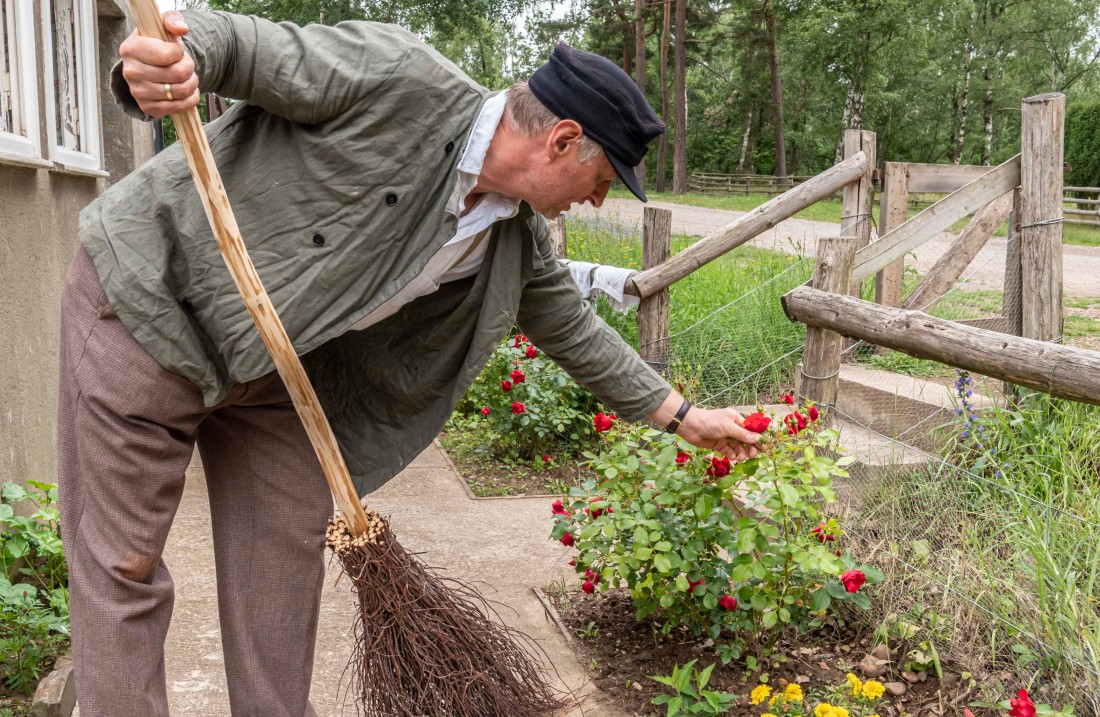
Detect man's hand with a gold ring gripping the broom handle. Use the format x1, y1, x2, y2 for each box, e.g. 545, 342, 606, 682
119, 10, 199, 118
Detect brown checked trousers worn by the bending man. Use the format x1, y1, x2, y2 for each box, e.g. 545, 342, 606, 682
58, 249, 332, 717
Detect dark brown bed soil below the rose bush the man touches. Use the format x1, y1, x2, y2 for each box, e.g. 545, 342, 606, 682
549, 591, 972, 717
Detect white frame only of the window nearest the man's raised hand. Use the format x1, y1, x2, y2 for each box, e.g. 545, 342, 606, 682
42, 0, 108, 177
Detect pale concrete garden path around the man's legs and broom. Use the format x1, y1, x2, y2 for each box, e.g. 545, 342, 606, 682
76, 444, 624, 717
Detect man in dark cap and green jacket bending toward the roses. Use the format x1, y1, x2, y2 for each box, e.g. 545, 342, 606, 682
59, 12, 759, 717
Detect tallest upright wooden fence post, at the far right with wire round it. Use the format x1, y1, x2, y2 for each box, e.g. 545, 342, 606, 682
1020, 92, 1066, 341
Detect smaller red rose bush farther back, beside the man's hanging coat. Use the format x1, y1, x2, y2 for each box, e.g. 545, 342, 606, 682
452, 334, 598, 463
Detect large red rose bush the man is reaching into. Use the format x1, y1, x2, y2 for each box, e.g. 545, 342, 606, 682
552, 407, 882, 659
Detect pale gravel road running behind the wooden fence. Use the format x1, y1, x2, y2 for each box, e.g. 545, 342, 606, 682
574, 199, 1100, 297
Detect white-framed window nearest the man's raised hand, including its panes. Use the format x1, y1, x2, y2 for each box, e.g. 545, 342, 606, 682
42, 0, 102, 175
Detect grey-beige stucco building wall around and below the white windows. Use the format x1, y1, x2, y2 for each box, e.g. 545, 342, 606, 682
0, 0, 152, 484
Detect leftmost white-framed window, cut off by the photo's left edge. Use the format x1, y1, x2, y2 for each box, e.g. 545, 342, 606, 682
0, 0, 48, 166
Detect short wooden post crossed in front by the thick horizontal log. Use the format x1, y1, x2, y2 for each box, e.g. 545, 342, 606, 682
798, 236, 861, 406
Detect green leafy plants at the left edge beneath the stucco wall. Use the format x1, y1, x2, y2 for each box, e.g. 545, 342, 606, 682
0, 481, 69, 693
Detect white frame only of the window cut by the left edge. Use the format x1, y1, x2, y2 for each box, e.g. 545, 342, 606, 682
0, 0, 53, 167
